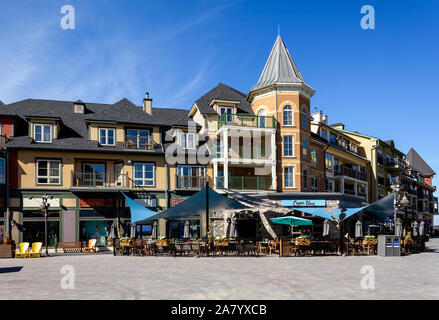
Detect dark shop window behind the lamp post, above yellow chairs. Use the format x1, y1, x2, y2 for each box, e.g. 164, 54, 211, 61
23, 211, 61, 247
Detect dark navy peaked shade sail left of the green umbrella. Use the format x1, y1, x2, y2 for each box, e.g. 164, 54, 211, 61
137, 187, 247, 224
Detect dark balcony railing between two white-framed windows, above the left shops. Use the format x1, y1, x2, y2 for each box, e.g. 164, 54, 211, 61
72, 172, 129, 189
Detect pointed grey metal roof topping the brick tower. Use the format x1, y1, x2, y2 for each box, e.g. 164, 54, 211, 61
250, 35, 306, 91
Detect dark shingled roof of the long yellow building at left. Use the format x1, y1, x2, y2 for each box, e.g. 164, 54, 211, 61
0, 99, 191, 152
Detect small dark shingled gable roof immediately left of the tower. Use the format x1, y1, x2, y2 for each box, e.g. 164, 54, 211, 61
195, 83, 254, 114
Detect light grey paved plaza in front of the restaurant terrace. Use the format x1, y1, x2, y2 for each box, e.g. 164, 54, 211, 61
0, 239, 439, 299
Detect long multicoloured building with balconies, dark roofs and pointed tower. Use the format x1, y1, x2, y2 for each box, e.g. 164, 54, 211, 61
0, 36, 437, 245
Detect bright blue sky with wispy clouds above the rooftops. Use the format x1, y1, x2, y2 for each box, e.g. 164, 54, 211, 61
0, 0, 439, 189
